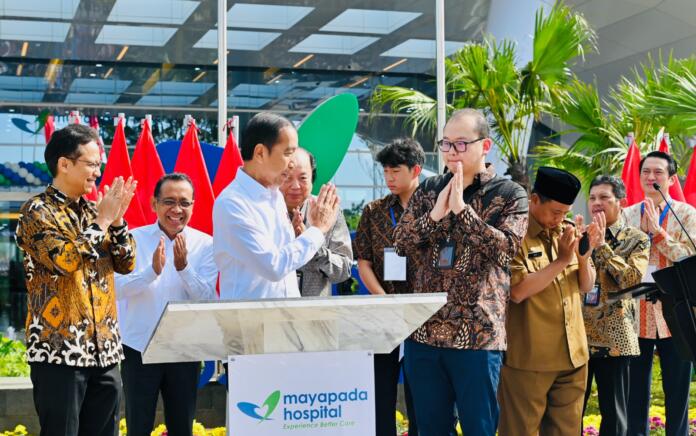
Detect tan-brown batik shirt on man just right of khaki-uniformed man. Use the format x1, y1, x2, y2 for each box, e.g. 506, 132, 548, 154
582, 217, 650, 357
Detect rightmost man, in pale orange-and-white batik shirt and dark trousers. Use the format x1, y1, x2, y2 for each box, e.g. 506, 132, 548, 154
625, 151, 696, 436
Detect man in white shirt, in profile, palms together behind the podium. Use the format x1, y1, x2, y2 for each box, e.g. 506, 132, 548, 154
213, 112, 339, 300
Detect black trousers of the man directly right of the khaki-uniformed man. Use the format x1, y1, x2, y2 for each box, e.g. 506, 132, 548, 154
580, 356, 633, 436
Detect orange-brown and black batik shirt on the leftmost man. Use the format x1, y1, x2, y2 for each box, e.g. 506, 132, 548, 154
16, 186, 135, 367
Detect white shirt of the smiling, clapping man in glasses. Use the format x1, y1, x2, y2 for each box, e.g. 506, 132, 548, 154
114, 223, 217, 352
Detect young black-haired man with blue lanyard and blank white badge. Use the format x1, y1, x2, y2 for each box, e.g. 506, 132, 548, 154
353, 138, 425, 435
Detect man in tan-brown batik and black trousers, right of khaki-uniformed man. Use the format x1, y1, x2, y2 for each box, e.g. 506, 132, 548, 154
582, 176, 650, 436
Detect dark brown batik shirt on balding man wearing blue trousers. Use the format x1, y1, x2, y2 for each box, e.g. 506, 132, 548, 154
395, 172, 527, 350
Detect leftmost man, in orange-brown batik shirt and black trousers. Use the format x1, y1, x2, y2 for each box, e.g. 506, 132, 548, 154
17, 124, 136, 436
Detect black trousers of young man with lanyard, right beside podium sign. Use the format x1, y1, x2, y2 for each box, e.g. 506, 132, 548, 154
374, 347, 418, 436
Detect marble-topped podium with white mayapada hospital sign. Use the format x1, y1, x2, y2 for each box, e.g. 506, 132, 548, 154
142, 293, 447, 436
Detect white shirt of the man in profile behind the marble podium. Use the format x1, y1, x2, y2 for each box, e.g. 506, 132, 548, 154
213, 169, 324, 300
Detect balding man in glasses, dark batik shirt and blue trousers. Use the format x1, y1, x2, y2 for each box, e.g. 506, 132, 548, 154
395, 109, 527, 436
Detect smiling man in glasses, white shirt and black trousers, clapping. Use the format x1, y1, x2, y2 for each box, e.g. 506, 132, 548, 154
115, 173, 217, 436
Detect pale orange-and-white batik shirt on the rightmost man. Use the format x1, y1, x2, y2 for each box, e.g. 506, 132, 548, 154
624, 199, 696, 339
